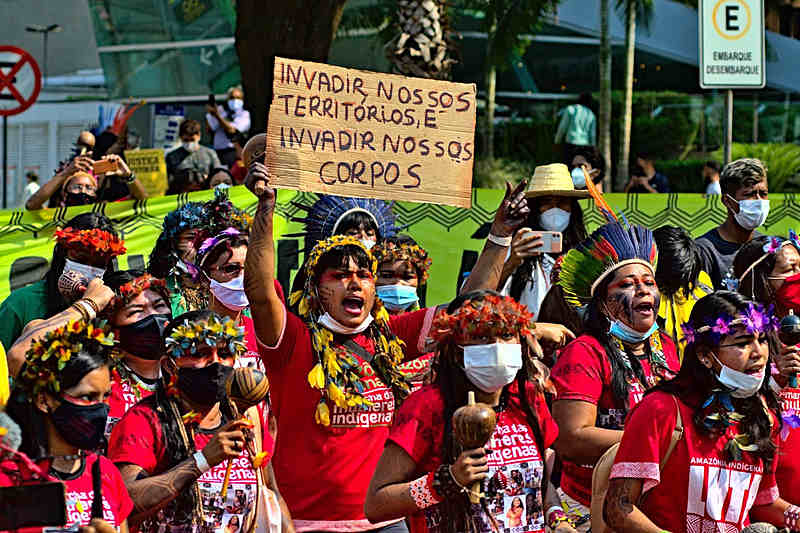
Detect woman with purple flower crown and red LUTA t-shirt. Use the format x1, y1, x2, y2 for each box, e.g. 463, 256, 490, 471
604, 291, 800, 533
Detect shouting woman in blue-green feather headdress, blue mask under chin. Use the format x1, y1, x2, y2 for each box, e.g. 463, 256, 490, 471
552, 222, 680, 530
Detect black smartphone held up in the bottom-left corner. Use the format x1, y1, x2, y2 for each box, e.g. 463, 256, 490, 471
0, 481, 67, 531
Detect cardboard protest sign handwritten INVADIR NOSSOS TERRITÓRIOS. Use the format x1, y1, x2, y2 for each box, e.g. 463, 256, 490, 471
266, 57, 475, 207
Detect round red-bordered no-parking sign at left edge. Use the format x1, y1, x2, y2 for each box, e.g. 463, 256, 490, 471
0, 46, 42, 116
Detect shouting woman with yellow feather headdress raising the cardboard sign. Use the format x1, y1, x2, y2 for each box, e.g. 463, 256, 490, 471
245, 163, 527, 532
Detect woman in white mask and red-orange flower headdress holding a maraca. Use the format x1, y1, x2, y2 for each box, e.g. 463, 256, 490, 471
364, 291, 574, 533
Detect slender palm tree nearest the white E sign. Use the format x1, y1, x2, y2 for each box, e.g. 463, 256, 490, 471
615, 0, 654, 189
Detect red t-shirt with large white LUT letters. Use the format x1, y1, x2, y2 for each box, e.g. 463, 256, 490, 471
610, 392, 778, 533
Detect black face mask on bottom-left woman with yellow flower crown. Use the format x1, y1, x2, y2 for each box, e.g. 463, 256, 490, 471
50, 400, 108, 450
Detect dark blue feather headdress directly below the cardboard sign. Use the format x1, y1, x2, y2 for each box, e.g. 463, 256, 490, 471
287, 194, 399, 250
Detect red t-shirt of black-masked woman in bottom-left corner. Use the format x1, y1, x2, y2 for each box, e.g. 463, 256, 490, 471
0, 454, 133, 533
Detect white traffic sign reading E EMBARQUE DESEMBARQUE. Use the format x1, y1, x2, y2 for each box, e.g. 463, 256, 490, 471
698, 0, 767, 89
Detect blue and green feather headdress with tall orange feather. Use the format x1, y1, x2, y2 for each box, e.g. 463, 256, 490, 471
558, 171, 658, 307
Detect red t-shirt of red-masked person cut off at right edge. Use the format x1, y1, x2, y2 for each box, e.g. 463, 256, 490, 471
775, 387, 800, 494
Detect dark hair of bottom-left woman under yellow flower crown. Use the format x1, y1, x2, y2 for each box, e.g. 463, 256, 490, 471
6, 349, 111, 459
